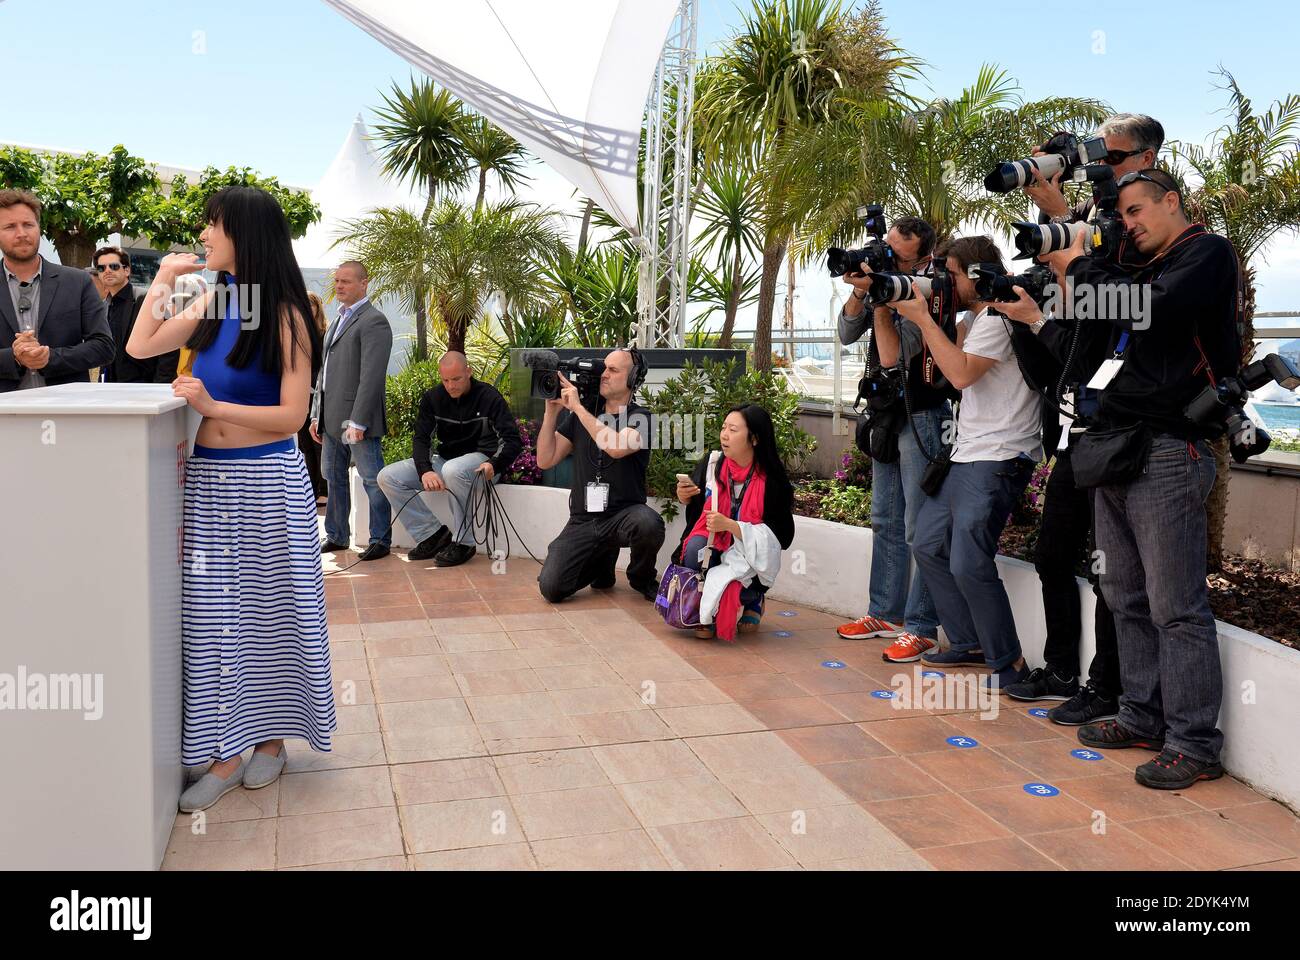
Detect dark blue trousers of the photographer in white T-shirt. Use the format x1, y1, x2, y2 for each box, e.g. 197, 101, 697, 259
911, 457, 1034, 670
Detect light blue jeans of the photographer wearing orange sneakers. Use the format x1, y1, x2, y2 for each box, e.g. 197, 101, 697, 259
867, 403, 952, 640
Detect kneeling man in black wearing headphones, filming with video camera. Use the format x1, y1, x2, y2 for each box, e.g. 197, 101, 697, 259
537, 347, 664, 604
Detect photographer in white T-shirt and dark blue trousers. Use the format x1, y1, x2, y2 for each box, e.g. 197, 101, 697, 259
897, 237, 1043, 691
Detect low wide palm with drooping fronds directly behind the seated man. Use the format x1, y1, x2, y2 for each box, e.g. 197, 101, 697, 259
338, 199, 563, 359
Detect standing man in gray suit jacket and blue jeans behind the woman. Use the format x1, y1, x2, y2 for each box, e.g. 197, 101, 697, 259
311, 260, 393, 561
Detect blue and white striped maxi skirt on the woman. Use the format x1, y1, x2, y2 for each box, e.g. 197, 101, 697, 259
181, 440, 338, 766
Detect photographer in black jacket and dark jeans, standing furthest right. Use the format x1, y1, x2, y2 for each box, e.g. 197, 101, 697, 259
1022, 168, 1240, 790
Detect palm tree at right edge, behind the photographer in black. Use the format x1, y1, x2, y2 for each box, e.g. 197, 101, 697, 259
1169, 69, 1300, 570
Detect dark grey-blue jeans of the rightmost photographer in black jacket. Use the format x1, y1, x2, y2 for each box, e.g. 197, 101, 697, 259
1095, 434, 1223, 762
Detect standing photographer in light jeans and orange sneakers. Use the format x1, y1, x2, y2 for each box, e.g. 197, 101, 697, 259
836, 217, 952, 662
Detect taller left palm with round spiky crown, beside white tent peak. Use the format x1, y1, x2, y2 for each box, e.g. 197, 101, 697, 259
372, 77, 469, 360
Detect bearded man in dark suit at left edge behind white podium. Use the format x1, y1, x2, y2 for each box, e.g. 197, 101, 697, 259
0, 190, 113, 393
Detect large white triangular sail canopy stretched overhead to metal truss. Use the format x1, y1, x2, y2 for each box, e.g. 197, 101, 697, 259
324, 0, 677, 233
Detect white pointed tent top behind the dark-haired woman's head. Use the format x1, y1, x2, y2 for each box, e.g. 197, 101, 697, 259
294, 116, 424, 268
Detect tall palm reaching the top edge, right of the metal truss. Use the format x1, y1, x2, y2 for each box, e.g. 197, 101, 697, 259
696, 0, 910, 371
